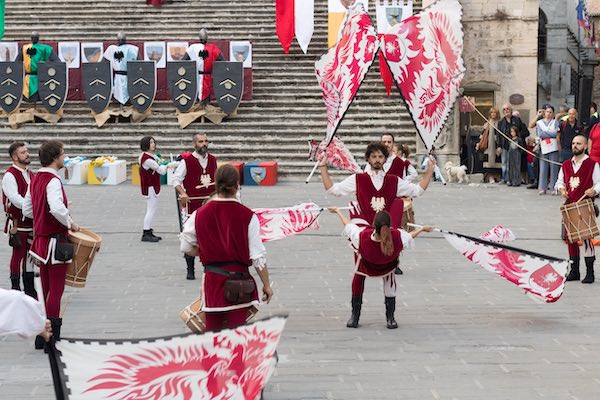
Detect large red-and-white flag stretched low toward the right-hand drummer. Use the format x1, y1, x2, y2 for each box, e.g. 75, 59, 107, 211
442, 231, 569, 303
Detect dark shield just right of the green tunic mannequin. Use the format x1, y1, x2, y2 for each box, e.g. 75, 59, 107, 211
38, 61, 68, 114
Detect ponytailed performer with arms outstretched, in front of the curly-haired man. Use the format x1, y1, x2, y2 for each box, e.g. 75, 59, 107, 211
329, 207, 432, 329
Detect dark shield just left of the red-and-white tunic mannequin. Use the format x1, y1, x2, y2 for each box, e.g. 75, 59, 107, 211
167, 60, 198, 112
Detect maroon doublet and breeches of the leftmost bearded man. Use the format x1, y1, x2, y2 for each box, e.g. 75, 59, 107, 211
2, 165, 33, 275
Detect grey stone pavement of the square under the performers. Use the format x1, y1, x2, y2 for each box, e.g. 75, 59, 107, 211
0, 182, 600, 400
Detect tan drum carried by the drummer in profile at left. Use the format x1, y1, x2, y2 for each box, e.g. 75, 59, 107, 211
65, 228, 102, 287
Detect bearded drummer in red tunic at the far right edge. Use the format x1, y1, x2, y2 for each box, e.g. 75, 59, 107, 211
556, 135, 600, 283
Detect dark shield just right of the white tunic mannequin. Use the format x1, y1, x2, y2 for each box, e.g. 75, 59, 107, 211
127, 61, 156, 113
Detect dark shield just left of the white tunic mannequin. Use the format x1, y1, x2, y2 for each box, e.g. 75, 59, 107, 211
82, 61, 112, 114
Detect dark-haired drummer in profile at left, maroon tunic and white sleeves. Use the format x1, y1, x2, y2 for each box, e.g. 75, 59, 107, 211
23, 140, 79, 348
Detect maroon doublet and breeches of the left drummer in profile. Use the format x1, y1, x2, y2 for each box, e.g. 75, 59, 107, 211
30, 172, 69, 318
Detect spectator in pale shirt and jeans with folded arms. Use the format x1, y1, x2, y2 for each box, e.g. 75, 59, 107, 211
536, 105, 560, 195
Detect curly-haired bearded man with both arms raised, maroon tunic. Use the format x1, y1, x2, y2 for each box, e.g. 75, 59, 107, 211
320, 143, 435, 327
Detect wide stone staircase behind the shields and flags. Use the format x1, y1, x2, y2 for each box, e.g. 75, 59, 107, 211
0, 0, 421, 179
